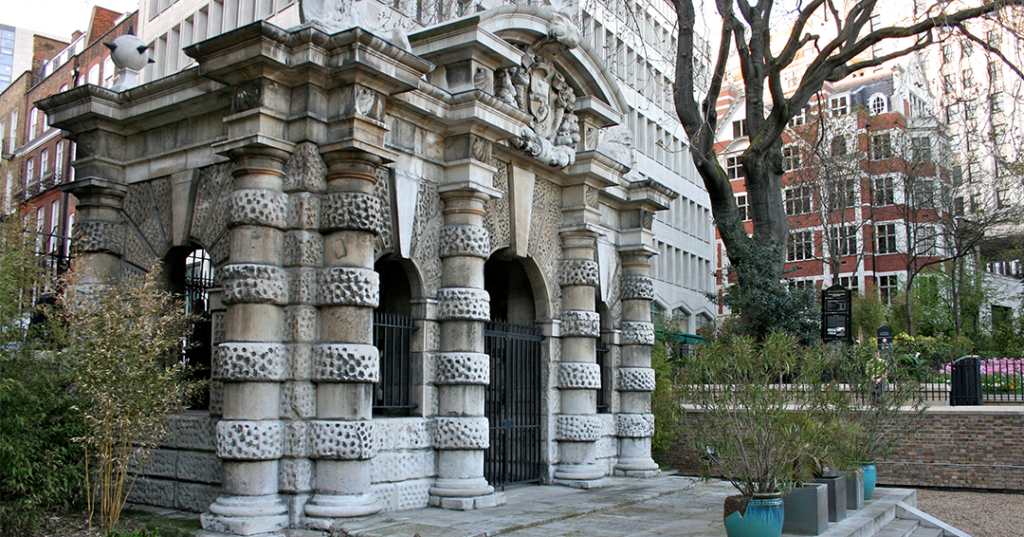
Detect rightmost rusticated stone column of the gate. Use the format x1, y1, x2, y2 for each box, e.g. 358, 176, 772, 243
615, 245, 657, 478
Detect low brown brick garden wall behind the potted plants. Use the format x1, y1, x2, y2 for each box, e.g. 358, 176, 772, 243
657, 405, 1024, 491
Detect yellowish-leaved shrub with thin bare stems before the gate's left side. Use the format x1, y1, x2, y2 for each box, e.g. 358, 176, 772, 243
63, 266, 201, 531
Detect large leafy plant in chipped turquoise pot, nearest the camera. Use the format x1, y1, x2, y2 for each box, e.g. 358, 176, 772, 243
677, 334, 833, 537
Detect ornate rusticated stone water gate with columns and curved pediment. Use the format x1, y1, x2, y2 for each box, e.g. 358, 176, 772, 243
40, 6, 676, 535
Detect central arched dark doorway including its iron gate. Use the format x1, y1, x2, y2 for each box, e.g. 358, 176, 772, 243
483, 255, 544, 488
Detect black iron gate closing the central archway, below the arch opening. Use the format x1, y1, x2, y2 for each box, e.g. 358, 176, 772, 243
483, 321, 543, 488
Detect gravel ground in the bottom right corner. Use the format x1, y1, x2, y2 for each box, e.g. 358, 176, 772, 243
918, 489, 1024, 537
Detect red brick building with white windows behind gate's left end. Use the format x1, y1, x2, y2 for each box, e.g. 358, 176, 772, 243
4, 7, 136, 268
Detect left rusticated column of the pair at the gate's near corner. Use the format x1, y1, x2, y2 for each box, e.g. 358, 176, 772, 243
203, 143, 289, 535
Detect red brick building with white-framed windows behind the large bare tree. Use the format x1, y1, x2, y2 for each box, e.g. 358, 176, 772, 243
716, 58, 946, 314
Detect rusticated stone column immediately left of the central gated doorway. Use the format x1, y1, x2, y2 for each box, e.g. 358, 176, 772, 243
430, 174, 504, 509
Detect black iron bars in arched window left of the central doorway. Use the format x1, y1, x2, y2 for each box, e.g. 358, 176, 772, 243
373, 312, 416, 416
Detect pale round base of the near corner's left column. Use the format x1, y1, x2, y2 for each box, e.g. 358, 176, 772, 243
201, 494, 289, 535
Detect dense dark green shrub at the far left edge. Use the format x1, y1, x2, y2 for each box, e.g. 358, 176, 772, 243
0, 217, 84, 535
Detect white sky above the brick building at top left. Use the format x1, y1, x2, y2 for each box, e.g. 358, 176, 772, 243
0, 0, 138, 41
